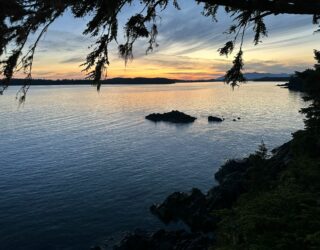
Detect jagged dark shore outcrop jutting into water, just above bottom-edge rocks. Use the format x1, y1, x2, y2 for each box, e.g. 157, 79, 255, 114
150, 160, 250, 232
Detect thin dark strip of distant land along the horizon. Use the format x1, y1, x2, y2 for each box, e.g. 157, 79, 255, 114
11, 72, 290, 86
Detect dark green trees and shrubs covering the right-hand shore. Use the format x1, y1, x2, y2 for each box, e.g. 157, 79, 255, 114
213, 51, 320, 250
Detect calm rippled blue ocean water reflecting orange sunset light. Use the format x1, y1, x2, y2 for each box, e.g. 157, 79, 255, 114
0, 83, 305, 250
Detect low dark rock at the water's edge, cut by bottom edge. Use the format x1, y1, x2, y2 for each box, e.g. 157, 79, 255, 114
113, 230, 214, 250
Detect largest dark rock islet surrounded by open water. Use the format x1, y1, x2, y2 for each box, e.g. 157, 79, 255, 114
145, 110, 197, 123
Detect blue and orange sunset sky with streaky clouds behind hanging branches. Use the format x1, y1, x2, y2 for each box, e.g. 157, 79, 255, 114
20, 0, 320, 80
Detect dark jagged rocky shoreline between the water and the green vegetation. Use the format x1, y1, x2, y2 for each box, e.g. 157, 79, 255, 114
92, 142, 291, 250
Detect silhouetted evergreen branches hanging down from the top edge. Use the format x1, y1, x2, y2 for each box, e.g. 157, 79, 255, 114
0, 0, 320, 101
